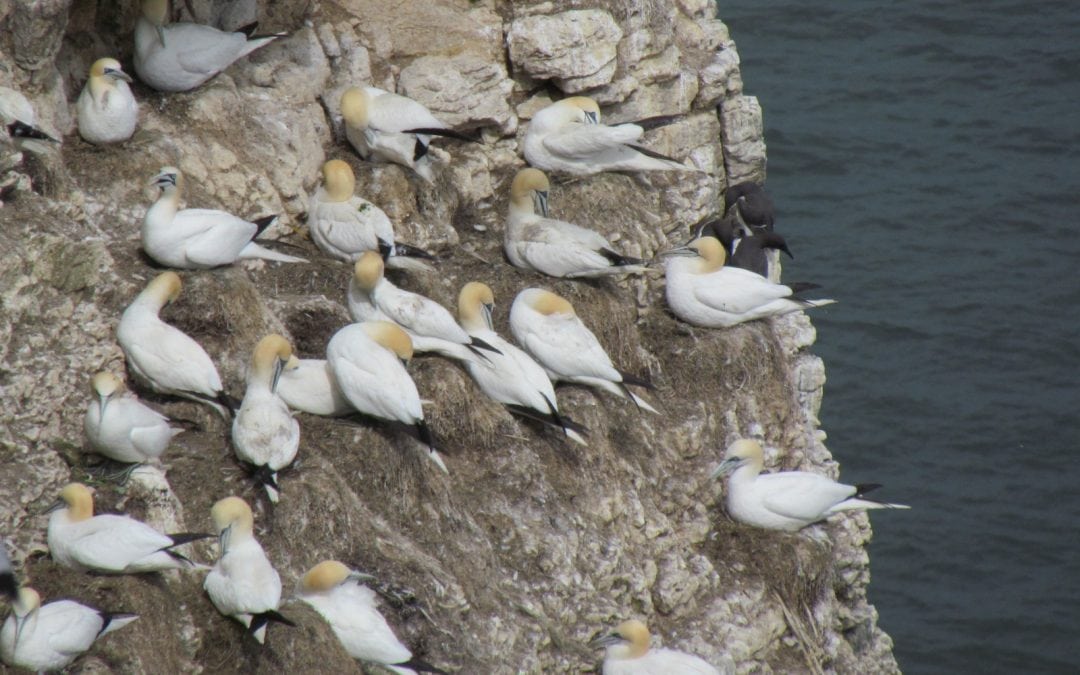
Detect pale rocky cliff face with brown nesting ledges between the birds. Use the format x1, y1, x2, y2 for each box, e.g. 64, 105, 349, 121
0, 0, 896, 673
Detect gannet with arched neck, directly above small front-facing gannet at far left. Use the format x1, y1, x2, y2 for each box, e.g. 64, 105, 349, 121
117, 272, 234, 419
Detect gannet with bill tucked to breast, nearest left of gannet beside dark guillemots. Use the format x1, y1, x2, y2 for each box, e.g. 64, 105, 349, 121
503, 168, 645, 278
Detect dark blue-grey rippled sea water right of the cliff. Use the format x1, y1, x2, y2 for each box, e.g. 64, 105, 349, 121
720, 0, 1080, 673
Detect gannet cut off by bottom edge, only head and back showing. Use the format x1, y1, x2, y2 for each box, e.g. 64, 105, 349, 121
592, 621, 720, 675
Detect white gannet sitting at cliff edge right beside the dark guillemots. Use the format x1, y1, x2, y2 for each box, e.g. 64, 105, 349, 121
665, 237, 836, 328
